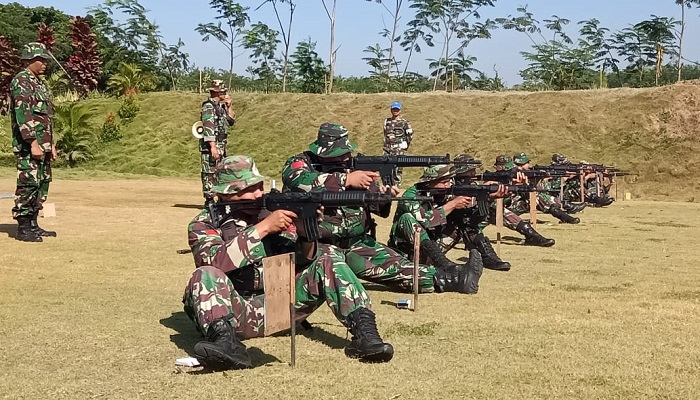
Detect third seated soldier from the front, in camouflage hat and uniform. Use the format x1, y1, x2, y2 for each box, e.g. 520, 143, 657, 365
389, 165, 483, 294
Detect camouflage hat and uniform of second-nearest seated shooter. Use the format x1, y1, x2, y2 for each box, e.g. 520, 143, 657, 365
282, 123, 435, 292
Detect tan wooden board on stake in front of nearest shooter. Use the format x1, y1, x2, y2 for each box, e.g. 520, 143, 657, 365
263, 253, 295, 335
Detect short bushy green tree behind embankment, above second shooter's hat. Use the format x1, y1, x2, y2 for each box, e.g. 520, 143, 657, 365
290, 38, 328, 93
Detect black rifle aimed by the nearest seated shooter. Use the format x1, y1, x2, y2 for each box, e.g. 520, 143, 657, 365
208, 189, 432, 241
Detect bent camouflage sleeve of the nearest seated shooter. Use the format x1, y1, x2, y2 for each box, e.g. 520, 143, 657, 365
188, 214, 267, 272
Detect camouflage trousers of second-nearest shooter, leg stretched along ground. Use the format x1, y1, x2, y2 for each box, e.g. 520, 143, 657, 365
330, 235, 435, 293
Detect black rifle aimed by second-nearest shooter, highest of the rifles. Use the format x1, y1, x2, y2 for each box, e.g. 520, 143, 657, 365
314, 154, 481, 186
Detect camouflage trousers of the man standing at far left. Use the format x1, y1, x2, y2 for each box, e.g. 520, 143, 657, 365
12, 153, 52, 219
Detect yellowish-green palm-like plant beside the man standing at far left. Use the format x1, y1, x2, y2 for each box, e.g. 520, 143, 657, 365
54, 104, 95, 167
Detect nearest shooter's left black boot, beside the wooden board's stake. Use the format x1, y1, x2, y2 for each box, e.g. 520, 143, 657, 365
194, 318, 252, 371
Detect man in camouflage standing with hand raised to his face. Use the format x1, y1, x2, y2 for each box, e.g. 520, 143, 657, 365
199, 80, 236, 202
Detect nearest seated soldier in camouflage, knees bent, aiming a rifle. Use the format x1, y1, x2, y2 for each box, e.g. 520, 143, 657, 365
182, 156, 394, 370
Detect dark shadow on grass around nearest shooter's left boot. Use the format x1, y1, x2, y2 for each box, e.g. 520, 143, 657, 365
160, 311, 282, 368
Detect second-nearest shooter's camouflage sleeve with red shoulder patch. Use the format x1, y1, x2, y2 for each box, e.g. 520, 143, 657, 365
282, 155, 347, 192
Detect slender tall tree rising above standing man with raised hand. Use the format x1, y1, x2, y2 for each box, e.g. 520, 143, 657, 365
195, 0, 250, 87
